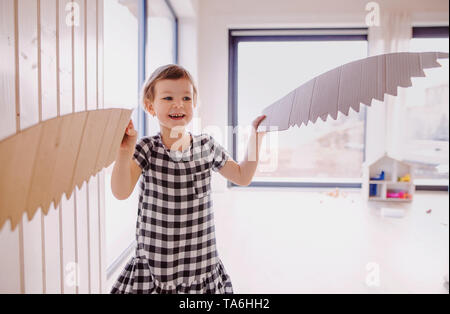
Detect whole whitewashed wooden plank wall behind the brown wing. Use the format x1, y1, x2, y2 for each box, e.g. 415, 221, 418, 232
0, 0, 106, 293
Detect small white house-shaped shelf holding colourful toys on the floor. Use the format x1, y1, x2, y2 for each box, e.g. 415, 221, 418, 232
362, 154, 415, 202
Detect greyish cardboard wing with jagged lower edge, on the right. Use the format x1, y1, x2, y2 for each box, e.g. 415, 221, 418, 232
258, 52, 448, 132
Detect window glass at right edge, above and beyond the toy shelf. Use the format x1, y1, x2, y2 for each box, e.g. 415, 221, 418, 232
403, 38, 449, 180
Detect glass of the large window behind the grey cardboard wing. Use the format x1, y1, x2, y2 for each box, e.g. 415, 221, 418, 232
237, 41, 367, 182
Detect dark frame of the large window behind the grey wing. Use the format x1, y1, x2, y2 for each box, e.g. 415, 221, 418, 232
227, 28, 369, 189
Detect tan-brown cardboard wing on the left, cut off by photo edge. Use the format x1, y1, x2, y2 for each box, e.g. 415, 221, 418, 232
0, 109, 132, 229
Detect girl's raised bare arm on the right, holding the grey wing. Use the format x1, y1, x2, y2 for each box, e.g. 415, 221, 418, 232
219, 115, 266, 186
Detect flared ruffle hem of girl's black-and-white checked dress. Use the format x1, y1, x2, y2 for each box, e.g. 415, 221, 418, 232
111, 257, 233, 294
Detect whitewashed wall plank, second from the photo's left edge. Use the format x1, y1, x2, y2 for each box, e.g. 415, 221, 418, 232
17, 0, 44, 293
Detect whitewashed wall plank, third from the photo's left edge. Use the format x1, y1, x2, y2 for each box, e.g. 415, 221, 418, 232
40, 0, 61, 294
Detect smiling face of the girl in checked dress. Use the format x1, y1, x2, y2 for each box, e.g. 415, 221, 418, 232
145, 78, 195, 129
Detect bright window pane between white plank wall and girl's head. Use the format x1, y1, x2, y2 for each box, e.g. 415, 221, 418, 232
104, 0, 139, 266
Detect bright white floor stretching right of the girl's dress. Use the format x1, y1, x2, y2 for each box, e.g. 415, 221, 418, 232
212, 188, 449, 293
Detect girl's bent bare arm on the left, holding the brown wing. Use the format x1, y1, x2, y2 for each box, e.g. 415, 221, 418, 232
111, 120, 142, 200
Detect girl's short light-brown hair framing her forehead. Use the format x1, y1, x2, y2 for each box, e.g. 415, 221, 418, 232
140, 64, 197, 112
